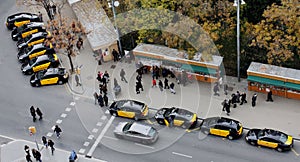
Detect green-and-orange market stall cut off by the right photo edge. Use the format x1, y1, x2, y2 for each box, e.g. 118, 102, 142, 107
247, 62, 300, 99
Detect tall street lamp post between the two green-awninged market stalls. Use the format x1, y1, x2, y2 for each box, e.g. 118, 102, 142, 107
233, 0, 246, 82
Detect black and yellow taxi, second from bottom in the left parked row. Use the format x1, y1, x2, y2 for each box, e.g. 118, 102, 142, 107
21, 54, 59, 75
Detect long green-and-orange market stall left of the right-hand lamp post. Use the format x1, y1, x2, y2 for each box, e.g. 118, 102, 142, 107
133, 44, 223, 82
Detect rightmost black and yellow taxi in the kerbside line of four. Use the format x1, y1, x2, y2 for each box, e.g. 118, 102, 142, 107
245, 128, 294, 152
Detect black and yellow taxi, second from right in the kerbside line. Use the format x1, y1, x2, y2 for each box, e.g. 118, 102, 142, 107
200, 117, 243, 140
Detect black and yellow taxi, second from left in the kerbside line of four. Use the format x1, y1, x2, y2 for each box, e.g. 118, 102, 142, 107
154, 107, 197, 128
